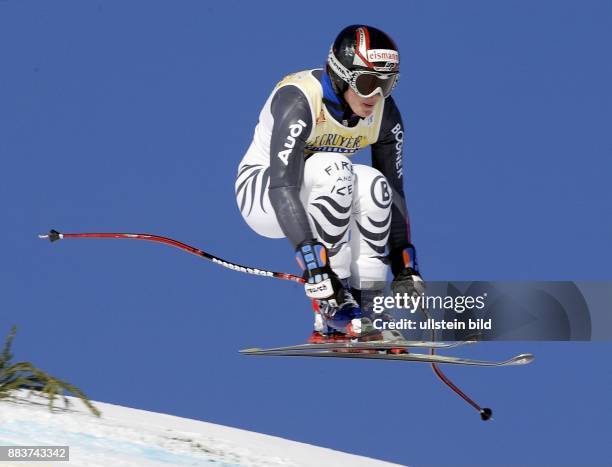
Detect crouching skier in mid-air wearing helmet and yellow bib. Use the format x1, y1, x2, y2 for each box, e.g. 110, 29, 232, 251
236, 25, 423, 343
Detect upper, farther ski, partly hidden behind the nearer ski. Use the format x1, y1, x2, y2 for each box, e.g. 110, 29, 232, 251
243, 340, 476, 353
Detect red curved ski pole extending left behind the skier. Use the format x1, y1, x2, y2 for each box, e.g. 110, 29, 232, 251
38, 229, 304, 283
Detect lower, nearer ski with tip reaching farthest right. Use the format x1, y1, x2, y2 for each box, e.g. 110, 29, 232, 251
240, 349, 534, 367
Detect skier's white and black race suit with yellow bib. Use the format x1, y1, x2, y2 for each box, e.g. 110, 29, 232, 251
236, 69, 410, 289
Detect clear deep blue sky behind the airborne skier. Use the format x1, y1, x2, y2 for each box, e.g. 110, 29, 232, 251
0, 0, 612, 465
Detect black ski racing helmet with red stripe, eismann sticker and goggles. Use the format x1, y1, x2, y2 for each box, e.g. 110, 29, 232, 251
326, 24, 399, 97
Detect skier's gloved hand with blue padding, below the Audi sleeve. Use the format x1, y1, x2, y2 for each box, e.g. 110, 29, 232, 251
295, 240, 343, 306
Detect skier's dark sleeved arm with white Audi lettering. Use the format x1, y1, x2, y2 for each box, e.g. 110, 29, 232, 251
269, 86, 315, 248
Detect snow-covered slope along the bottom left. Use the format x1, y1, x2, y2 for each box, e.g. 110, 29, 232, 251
0, 391, 397, 467
